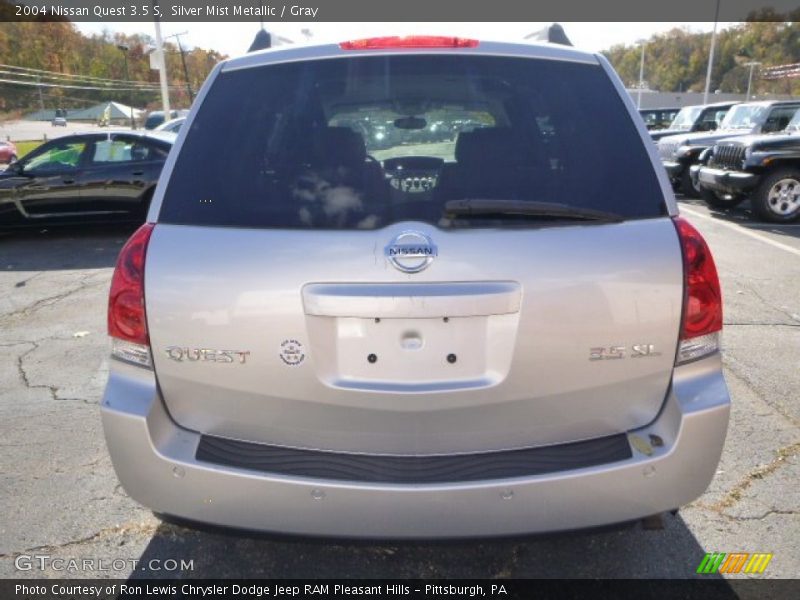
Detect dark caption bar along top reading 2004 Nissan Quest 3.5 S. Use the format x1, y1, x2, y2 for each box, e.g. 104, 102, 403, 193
0, 0, 800, 23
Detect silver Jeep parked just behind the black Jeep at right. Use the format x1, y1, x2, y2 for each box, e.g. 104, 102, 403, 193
658, 100, 800, 198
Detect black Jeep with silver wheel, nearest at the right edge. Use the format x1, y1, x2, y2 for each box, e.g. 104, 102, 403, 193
691, 106, 800, 223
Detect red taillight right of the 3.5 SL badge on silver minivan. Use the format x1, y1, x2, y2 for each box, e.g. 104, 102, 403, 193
674, 217, 722, 364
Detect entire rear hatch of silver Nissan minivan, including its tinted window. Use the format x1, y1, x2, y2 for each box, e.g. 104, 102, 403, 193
145, 46, 683, 455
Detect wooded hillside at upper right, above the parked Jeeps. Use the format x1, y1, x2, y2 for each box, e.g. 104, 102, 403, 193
603, 17, 800, 95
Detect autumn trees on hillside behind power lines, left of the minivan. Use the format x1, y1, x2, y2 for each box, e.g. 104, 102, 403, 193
0, 22, 225, 112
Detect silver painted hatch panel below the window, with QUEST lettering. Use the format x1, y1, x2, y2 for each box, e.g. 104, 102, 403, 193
145, 218, 683, 454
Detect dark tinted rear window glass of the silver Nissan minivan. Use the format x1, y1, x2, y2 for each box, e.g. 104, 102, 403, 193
159, 55, 665, 229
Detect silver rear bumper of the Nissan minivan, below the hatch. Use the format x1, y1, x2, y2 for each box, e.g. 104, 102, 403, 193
101, 355, 730, 538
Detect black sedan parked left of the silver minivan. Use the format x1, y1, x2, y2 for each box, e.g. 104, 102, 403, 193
0, 131, 176, 228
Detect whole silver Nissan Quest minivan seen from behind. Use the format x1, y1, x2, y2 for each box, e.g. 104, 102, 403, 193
102, 37, 730, 538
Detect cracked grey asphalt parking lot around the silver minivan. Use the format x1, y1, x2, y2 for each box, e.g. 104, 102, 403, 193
0, 197, 800, 578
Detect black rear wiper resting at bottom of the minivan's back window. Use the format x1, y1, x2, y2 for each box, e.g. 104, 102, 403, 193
444, 198, 625, 223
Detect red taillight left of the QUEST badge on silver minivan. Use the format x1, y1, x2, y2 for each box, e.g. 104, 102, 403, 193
108, 223, 155, 367
